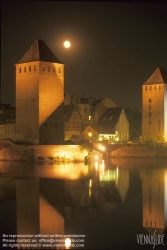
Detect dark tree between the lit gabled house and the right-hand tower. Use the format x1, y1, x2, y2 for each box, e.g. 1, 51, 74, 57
125, 108, 142, 141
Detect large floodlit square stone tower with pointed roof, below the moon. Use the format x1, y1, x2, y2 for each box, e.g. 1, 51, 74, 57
15, 40, 64, 144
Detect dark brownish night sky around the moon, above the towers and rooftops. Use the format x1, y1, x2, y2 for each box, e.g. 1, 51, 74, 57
1, 0, 167, 110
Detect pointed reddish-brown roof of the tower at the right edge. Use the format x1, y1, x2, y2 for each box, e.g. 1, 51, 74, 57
144, 67, 167, 85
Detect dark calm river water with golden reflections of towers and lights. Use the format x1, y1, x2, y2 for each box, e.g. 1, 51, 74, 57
0, 158, 167, 249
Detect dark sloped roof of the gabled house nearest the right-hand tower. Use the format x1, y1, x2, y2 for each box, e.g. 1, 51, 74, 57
99, 107, 122, 126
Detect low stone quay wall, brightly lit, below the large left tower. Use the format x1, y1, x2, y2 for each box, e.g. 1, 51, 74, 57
0, 140, 88, 162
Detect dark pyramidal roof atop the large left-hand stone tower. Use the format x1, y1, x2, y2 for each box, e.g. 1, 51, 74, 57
18, 40, 62, 64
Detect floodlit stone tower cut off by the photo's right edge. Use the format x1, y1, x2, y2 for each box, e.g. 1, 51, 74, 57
142, 68, 167, 142
